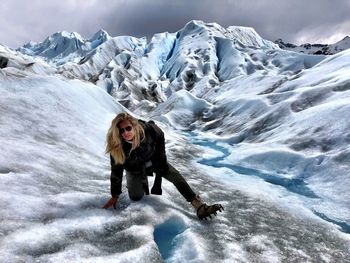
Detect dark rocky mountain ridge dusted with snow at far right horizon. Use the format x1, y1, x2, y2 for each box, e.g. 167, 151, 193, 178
275, 36, 350, 55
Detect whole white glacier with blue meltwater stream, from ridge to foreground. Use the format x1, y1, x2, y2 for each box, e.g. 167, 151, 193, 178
0, 21, 350, 262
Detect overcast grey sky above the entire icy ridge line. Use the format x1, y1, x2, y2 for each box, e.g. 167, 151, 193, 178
0, 0, 350, 48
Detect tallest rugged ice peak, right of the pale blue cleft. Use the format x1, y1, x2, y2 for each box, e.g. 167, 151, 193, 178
157, 21, 316, 97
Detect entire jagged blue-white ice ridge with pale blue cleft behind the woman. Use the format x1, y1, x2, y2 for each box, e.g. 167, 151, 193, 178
34, 20, 286, 111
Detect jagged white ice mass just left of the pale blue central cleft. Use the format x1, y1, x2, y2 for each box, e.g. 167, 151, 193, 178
71, 33, 175, 111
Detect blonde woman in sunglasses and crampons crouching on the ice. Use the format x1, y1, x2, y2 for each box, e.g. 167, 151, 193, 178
103, 113, 223, 219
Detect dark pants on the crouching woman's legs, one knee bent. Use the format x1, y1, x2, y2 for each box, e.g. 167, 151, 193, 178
126, 163, 196, 202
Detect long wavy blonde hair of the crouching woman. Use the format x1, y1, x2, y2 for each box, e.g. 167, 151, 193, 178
106, 112, 145, 164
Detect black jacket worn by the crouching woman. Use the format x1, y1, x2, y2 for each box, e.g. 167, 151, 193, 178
110, 120, 169, 196
